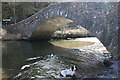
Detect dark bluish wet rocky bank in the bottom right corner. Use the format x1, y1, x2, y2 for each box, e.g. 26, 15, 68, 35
81, 60, 120, 80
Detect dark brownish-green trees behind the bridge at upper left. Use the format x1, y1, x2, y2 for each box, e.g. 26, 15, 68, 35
2, 2, 51, 25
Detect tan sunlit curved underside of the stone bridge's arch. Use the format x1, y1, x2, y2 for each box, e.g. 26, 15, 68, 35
30, 17, 76, 40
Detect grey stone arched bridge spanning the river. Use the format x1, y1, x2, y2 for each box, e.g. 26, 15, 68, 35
4, 2, 119, 58
